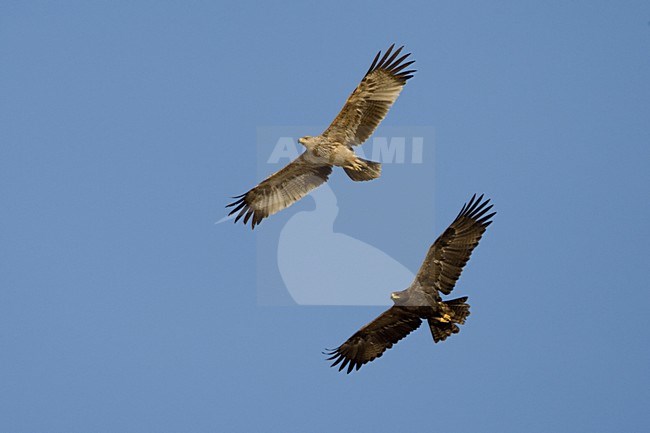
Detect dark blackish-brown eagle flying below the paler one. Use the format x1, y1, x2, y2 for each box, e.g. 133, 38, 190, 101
325, 194, 496, 373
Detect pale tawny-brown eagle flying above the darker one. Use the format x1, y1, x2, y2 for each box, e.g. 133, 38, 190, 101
226, 44, 415, 229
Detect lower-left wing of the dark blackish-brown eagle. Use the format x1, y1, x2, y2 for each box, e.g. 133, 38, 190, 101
325, 306, 422, 373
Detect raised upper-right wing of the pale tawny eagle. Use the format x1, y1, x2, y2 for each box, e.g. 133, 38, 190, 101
323, 44, 415, 146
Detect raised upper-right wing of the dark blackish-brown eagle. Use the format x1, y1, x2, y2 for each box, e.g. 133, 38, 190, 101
415, 194, 496, 295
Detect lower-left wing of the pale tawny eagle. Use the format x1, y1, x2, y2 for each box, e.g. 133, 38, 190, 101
226, 153, 332, 229
